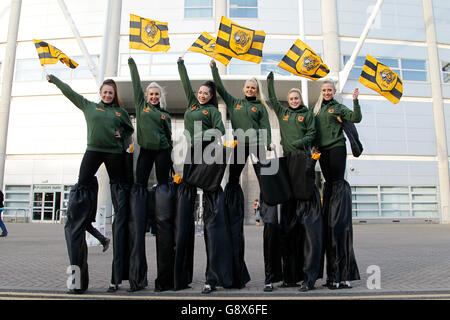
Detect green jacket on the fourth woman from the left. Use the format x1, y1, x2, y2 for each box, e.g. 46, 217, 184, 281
211, 63, 272, 147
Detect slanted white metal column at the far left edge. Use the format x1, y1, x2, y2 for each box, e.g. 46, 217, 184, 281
0, 0, 22, 190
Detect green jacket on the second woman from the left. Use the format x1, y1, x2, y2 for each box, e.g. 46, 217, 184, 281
128, 58, 173, 150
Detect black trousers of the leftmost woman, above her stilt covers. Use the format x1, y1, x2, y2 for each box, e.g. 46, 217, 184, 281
78, 151, 125, 186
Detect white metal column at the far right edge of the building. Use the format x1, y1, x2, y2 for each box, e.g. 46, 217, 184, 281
422, 0, 450, 223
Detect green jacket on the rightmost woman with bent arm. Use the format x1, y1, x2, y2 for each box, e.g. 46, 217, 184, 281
315, 99, 362, 150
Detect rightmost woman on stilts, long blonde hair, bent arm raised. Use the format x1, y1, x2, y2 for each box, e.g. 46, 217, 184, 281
313, 80, 362, 289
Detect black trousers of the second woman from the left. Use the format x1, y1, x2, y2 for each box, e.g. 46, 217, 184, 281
136, 147, 172, 186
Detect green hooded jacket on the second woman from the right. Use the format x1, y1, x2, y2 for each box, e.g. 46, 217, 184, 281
267, 72, 316, 154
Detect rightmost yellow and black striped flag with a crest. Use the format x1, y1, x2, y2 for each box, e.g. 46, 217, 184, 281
359, 55, 403, 104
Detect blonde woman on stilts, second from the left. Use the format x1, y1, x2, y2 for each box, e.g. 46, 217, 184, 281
128, 57, 175, 291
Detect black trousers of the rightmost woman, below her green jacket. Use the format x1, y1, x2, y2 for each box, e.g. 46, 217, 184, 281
319, 146, 347, 182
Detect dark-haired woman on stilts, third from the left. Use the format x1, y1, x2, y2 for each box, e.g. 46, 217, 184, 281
175, 58, 233, 294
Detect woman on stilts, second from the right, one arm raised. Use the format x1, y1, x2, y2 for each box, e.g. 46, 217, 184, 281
266, 72, 322, 291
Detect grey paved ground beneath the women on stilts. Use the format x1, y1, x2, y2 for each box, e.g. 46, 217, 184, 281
0, 223, 450, 300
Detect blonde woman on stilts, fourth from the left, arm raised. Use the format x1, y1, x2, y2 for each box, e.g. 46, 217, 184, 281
210, 60, 274, 289
